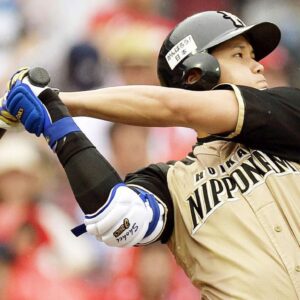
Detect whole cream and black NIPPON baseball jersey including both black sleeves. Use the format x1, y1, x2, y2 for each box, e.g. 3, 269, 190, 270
126, 86, 300, 300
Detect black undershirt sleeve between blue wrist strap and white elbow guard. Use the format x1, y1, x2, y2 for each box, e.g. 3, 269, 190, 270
56, 132, 122, 214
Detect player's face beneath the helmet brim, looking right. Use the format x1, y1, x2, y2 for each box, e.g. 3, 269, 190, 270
212, 36, 268, 89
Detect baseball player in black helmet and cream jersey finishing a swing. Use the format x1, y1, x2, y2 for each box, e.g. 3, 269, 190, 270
2, 11, 300, 300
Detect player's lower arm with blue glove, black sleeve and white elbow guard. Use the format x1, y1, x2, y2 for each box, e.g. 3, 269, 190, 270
7, 69, 169, 247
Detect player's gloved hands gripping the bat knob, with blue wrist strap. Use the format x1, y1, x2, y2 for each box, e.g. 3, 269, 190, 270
6, 68, 80, 149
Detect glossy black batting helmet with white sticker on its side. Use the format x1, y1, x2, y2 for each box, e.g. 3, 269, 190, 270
157, 11, 281, 90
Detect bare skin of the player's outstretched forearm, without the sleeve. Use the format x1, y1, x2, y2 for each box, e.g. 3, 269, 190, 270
59, 86, 239, 134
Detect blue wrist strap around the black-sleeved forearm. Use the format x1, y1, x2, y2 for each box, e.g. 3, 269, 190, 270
43, 117, 81, 149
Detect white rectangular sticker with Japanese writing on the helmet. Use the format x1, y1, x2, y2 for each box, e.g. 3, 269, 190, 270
165, 35, 197, 70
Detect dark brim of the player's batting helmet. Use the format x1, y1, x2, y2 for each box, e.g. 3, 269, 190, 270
203, 22, 281, 61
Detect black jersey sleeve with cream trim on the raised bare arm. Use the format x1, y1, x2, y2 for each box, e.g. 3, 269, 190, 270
213, 85, 300, 162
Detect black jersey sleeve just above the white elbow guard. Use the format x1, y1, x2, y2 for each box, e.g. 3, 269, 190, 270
125, 163, 174, 243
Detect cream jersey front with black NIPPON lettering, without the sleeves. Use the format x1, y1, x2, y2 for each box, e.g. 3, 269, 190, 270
167, 141, 300, 300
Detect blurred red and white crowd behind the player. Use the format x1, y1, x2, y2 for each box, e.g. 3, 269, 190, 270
0, 0, 300, 300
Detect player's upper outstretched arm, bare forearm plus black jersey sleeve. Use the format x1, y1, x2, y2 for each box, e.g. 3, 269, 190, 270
60, 85, 300, 161
